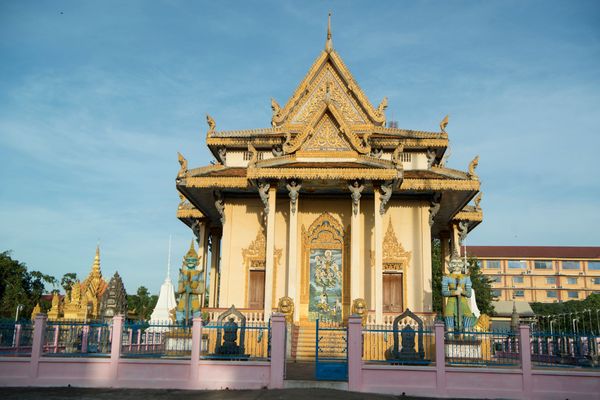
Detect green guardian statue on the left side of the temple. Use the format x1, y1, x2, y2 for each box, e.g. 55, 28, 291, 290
175, 240, 202, 324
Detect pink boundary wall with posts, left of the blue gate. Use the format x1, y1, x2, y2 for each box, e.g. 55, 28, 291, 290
0, 315, 285, 389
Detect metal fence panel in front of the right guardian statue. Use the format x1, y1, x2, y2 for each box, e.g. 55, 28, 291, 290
444, 331, 521, 367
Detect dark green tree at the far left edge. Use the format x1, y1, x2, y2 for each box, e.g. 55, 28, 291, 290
0, 251, 57, 318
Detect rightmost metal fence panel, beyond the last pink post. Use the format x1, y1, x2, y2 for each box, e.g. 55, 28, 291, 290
531, 332, 600, 368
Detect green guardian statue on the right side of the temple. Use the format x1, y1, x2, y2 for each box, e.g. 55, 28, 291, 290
442, 254, 475, 331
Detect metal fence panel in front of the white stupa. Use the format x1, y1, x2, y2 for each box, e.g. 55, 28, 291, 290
121, 321, 192, 359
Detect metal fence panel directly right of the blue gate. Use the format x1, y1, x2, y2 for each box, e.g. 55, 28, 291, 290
362, 324, 435, 365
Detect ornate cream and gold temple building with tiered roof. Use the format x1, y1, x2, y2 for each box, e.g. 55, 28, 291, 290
176, 19, 482, 323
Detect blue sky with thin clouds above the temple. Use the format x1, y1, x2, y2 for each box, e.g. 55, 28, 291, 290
0, 0, 600, 292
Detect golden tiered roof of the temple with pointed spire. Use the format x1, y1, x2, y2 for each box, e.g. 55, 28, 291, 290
177, 16, 481, 231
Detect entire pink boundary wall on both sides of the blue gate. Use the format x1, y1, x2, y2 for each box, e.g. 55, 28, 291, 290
0, 314, 600, 400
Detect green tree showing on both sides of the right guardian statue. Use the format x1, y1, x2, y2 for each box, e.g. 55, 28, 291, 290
431, 239, 495, 315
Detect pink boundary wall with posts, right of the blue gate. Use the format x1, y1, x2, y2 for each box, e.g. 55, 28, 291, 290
348, 316, 600, 400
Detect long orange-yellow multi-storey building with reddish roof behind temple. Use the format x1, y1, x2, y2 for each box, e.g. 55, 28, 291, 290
467, 246, 600, 303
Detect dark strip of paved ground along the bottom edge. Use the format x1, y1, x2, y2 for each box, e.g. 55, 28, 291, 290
0, 387, 468, 400
